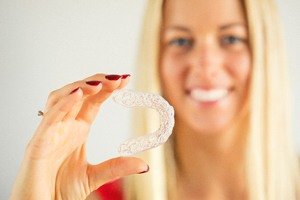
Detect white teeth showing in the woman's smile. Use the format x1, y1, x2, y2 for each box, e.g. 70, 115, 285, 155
191, 89, 228, 102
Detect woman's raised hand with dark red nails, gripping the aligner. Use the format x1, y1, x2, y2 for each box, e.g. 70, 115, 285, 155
11, 74, 149, 200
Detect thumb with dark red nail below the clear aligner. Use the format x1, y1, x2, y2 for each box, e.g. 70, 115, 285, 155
88, 157, 149, 191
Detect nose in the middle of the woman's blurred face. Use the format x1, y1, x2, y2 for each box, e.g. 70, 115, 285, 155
190, 42, 222, 79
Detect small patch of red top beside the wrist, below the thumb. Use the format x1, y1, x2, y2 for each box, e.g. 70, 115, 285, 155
96, 179, 124, 200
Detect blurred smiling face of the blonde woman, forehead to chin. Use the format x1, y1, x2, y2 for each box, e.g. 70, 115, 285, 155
159, 0, 251, 133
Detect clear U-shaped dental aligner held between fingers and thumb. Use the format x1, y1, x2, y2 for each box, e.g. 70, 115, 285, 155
113, 89, 174, 156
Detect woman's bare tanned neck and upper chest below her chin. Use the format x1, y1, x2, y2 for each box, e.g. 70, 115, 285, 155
174, 119, 245, 199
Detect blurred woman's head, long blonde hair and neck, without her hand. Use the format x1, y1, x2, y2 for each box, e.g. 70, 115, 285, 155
123, 0, 300, 199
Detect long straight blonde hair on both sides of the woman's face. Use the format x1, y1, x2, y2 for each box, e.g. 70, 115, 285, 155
125, 0, 300, 200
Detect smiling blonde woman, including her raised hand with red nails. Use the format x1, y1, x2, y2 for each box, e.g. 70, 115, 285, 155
12, 0, 300, 200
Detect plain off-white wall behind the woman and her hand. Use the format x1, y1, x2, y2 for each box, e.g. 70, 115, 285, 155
0, 0, 300, 199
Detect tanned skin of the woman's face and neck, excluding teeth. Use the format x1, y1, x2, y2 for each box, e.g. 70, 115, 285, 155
159, 0, 251, 199
